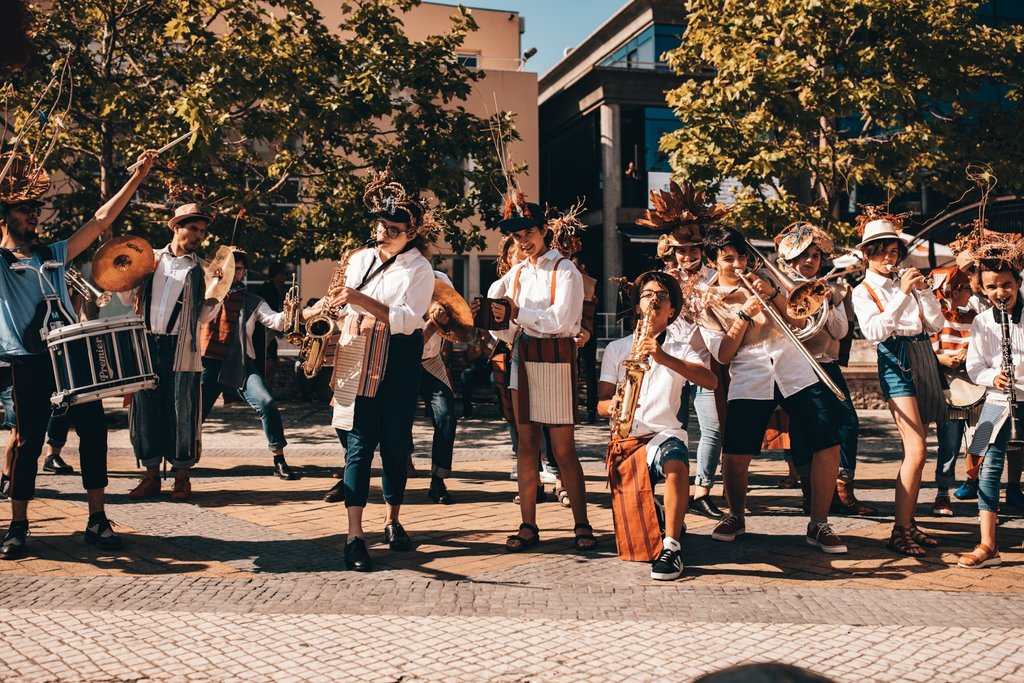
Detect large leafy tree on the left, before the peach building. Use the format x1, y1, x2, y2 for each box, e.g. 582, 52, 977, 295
4, 0, 510, 258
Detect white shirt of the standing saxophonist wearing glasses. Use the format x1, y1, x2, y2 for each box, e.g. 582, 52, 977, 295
337, 248, 434, 335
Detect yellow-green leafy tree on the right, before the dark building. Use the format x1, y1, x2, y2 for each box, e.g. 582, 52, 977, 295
662, 0, 1024, 240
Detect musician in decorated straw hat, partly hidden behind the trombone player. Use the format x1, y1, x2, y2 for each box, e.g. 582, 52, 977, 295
775, 221, 878, 515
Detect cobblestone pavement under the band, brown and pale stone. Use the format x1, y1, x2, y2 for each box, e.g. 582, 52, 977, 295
0, 403, 1024, 682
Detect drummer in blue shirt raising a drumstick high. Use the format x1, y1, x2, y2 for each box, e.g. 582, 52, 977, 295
0, 150, 157, 559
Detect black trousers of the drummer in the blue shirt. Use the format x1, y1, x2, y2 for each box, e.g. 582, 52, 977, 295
10, 353, 106, 501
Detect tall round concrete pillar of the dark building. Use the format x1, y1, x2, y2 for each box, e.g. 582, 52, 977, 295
601, 103, 623, 313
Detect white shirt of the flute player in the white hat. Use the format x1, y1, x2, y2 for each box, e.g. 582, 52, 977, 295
853, 270, 946, 344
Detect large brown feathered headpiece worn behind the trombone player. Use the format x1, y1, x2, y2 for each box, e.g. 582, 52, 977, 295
637, 180, 732, 247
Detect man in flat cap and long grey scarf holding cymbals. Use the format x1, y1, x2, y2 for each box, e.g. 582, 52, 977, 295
121, 204, 220, 501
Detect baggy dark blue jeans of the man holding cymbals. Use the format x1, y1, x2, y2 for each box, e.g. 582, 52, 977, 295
129, 334, 201, 469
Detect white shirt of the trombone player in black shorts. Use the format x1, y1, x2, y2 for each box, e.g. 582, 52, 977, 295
699, 318, 818, 400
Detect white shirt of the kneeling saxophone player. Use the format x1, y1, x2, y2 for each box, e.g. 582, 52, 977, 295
600, 335, 711, 463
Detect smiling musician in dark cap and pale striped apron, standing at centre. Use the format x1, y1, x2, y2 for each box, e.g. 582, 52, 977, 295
492, 197, 597, 553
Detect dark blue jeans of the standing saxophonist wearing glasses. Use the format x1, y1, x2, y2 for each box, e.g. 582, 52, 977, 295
336, 332, 423, 508
